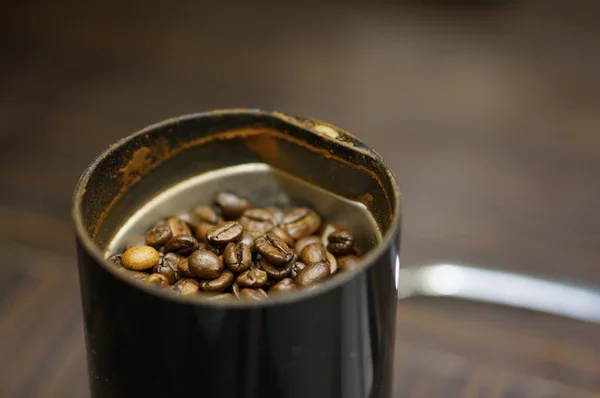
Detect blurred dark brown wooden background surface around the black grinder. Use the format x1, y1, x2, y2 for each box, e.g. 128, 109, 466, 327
0, 0, 600, 398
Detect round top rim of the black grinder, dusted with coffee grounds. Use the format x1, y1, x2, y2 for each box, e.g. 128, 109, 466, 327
71, 109, 402, 309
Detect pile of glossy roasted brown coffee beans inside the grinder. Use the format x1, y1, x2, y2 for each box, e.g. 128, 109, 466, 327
108, 192, 359, 300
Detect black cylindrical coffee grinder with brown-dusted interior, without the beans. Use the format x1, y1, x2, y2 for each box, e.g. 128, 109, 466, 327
73, 110, 400, 398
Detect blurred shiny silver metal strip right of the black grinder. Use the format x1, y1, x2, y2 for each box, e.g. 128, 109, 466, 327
398, 263, 600, 323
